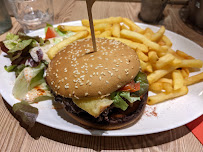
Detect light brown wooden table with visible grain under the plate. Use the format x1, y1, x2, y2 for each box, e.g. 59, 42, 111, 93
0, 0, 203, 152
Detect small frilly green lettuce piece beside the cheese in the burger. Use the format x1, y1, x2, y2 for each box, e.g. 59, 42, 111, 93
111, 92, 128, 111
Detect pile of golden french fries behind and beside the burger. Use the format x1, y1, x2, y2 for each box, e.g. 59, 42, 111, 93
48, 17, 203, 105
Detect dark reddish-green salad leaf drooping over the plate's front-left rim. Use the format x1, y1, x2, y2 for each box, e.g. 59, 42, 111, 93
13, 102, 39, 127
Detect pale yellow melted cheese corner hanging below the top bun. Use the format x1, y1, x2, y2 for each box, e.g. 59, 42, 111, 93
73, 97, 113, 118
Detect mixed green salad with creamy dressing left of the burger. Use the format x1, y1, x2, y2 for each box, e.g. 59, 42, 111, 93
0, 24, 74, 127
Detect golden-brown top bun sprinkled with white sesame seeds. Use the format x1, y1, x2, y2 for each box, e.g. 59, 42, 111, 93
46, 38, 140, 99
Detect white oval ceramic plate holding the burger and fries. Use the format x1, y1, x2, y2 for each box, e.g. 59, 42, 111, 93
0, 21, 203, 136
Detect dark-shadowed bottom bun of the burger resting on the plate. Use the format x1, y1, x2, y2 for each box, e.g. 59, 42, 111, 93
65, 92, 148, 130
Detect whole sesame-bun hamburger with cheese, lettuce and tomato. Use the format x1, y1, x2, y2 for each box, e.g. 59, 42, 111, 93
46, 38, 148, 130
